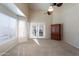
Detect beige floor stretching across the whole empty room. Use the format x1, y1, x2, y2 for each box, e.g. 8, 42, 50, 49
3, 39, 79, 56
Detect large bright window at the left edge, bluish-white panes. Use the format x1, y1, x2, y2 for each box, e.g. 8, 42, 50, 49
0, 13, 17, 42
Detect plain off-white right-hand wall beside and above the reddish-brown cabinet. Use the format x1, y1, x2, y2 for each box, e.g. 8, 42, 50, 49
52, 3, 79, 48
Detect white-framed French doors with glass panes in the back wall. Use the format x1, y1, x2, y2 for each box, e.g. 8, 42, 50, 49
30, 23, 45, 38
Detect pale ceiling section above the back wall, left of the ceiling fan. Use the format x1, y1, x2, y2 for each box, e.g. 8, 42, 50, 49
29, 3, 50, 11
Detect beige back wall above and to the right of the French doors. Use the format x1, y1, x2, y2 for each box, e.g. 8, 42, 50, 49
29, 11, 52, 39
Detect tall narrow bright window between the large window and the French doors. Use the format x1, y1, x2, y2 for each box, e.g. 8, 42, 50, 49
18, 16, 29, 43
